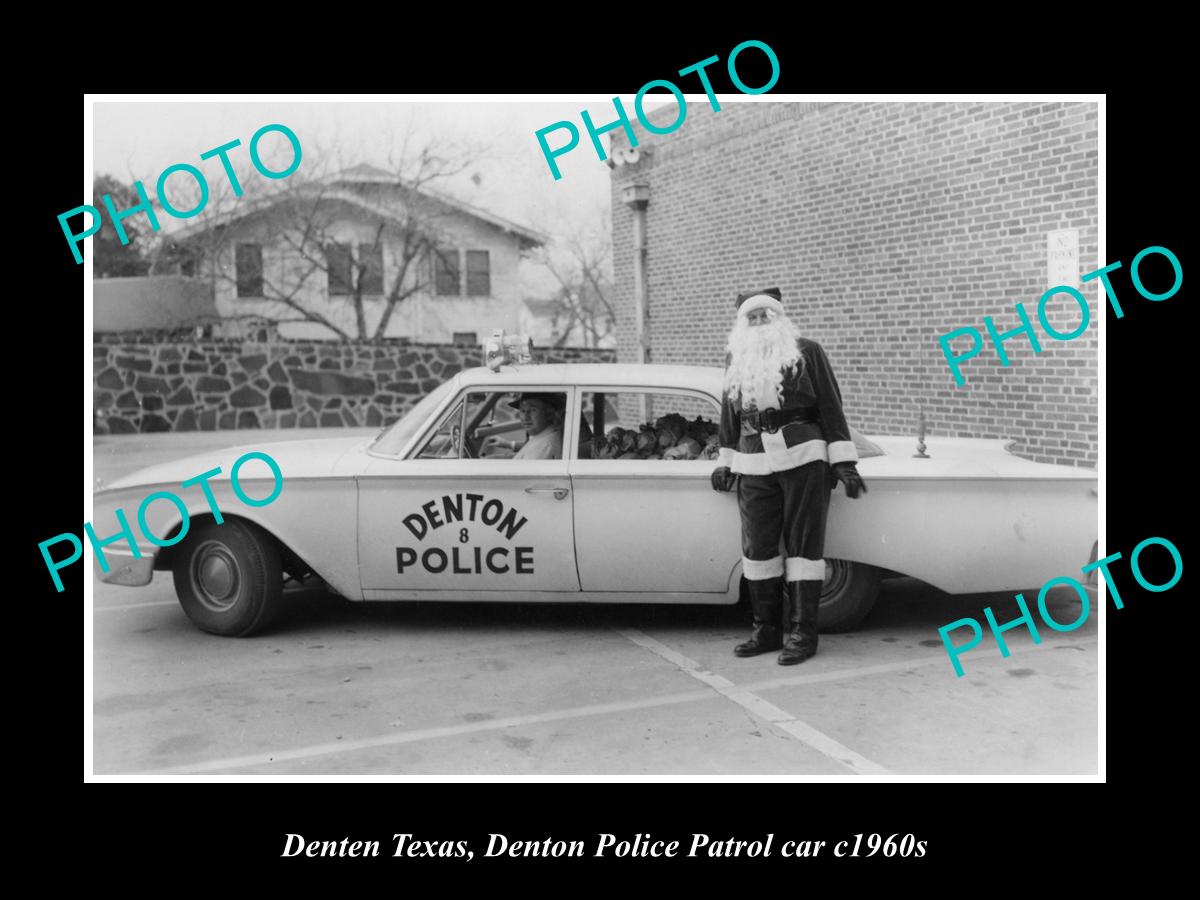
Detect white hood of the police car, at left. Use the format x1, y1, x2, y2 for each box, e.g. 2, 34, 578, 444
97, 434, 371, 493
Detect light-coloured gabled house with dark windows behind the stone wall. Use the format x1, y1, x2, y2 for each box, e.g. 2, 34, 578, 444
165, 164, 547, 343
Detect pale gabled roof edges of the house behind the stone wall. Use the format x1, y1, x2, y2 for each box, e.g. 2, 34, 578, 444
174, 163, 550, 250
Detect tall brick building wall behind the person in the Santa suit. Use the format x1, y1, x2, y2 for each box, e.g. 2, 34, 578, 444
612, 103, 1106, 466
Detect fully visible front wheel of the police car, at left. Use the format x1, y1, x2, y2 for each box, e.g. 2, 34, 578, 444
174, 518, 283, 637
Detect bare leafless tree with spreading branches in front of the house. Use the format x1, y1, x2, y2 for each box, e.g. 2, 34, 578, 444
158, 130, 482, 341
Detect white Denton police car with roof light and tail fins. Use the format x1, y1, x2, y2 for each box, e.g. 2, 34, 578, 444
95, 336, 1097, 636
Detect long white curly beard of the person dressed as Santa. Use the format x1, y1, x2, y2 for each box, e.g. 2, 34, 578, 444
725, 314, 804, 409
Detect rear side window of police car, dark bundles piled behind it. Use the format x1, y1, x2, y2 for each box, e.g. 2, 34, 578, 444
578, 390, 721, 461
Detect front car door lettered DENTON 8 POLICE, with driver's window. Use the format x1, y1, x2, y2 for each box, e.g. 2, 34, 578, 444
358, 388, 580, 599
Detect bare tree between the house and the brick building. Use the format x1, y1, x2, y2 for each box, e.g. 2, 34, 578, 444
534, 212, 617, 347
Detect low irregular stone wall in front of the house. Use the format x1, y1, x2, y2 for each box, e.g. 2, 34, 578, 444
92, 334, 616, 434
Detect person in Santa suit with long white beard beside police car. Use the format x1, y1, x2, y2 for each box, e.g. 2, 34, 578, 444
713, 288, 866, 666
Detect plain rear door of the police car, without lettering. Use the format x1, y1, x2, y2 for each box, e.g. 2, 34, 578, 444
571, 386, 742, 594
